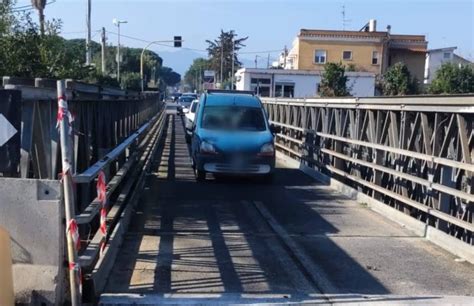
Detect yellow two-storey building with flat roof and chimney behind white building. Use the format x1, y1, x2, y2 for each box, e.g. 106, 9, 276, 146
284, 20, 428, 81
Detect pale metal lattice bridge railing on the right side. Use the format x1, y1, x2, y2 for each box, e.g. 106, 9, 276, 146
262, 96, 474, 250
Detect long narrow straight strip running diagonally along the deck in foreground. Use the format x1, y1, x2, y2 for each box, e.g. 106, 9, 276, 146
251, 201, 338, 301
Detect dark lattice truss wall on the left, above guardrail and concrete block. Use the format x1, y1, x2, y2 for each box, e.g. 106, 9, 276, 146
0, 77, 161, 179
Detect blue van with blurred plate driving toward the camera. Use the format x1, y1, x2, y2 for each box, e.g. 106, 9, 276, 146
191, 90, 278, 181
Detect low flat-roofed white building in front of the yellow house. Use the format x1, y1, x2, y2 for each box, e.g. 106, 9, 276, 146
235, 68, 375, 98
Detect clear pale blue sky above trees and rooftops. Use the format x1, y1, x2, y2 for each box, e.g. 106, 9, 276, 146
16, 0, 474, 73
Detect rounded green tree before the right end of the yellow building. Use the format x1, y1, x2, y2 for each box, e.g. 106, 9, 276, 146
381, 63, 418, 96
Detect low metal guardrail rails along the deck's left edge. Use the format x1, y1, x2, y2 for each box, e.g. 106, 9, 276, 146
80, 109, 167, 298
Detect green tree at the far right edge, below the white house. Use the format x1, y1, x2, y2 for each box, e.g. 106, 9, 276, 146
428, 63, 474, 94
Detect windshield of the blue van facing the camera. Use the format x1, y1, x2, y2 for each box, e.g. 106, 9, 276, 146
202, 106, 266, 131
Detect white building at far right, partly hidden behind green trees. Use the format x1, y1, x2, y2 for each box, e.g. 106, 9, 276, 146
424, 47, 471, 84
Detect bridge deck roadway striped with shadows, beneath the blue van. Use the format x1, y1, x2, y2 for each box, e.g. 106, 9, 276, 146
101, 116, 474, 304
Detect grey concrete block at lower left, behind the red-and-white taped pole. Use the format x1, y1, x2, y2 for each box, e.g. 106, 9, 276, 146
0, 178, 66, 306
